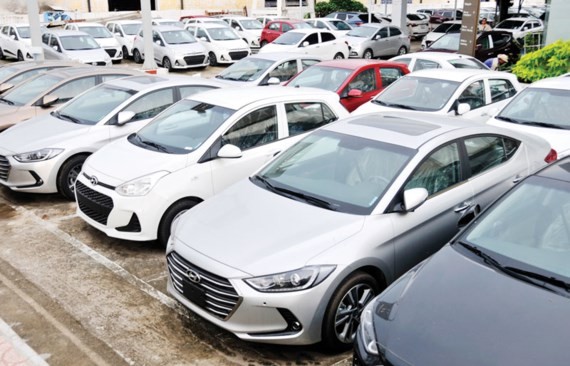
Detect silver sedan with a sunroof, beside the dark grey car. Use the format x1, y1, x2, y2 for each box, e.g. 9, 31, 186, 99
166, 112, 550, 352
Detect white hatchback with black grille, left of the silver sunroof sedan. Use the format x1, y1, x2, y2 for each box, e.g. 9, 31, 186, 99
77, 87, 348, 245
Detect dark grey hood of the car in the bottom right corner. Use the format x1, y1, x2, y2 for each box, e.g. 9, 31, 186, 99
374, 245, 570, 366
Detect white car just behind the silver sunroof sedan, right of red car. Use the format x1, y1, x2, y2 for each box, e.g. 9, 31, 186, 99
353, 69, 522, 122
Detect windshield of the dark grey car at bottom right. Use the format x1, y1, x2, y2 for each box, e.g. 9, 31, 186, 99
460, 176, 570, 283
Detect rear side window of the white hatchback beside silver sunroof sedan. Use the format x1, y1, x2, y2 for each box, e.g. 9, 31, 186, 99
285, 102, 338, 136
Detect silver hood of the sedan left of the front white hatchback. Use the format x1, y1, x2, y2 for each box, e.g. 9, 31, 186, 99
0, 114, 87, 154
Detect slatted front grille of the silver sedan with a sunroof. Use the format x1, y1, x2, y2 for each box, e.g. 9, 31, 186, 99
166, 252, 240, 320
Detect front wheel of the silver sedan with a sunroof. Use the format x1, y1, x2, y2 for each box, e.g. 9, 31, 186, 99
321, 271, 380, 351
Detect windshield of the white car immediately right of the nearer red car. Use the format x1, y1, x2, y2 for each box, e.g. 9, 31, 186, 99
373, 76, 460, 112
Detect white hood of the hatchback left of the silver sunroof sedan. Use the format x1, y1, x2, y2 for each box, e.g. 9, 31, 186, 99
83, 137, 188, 186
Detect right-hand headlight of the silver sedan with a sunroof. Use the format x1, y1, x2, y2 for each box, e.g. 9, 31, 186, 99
244, 266, 336, 292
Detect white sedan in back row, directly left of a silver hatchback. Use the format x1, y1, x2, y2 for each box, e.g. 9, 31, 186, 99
259, 28, 348, 60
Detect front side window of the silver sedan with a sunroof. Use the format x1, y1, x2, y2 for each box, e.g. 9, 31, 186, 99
405, 143, 461, 196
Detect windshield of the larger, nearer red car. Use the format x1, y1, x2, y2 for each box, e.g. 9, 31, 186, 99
287, 65, 354, 92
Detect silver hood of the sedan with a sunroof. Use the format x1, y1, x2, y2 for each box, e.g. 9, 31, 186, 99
174, 179, 365, 276
